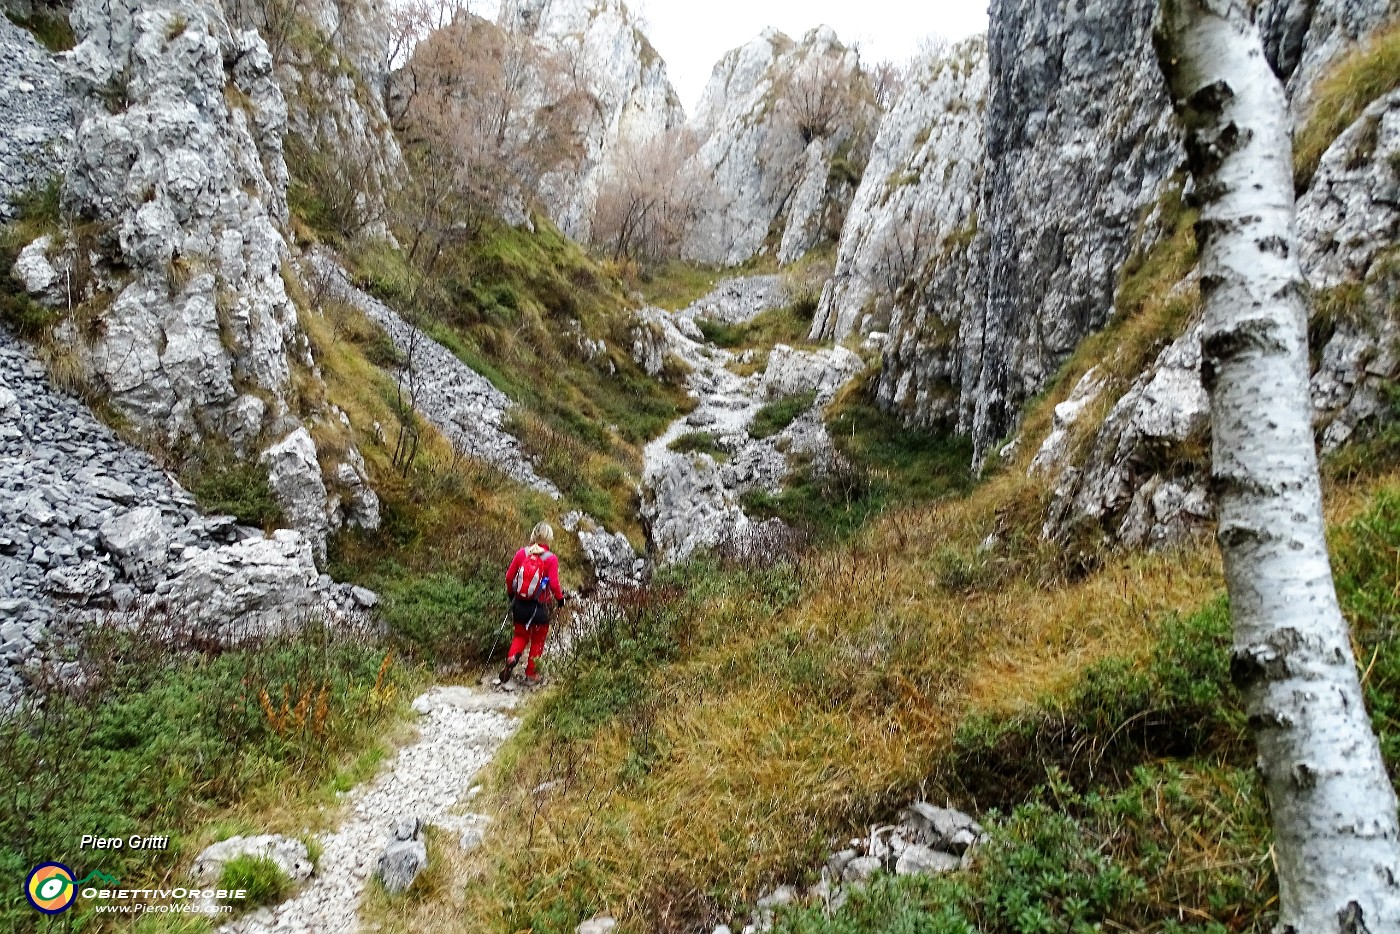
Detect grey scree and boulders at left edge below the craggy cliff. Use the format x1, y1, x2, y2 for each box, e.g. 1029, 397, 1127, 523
0, 330, 375, 709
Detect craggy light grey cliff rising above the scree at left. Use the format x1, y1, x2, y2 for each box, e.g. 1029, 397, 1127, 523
6, 0, 378, 552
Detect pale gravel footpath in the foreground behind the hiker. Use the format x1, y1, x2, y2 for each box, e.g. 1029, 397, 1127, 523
220, 686, 517, 934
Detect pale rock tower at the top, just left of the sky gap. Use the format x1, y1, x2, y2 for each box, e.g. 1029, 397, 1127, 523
500, 0, 686, 241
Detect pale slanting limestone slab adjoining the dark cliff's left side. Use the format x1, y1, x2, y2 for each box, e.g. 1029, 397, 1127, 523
812, 36, 987, 340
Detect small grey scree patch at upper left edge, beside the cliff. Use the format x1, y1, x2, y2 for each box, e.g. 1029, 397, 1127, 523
0, 17, 73, 221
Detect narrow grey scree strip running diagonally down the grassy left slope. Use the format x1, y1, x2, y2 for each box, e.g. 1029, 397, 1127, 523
307, 249, 560, 500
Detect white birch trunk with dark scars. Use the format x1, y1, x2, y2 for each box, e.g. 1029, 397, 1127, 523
1156, 0, 1400, 934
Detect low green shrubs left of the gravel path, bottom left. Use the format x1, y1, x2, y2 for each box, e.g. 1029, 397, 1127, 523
0, 613, 410, 931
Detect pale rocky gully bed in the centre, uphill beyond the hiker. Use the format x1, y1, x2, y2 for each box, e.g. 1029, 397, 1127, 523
634, 276, 864, 560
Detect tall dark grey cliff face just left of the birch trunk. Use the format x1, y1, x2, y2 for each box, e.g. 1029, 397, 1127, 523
959, 0, 1183, 461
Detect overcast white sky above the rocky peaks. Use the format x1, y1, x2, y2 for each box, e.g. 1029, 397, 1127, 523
472, 0, 987, 113
